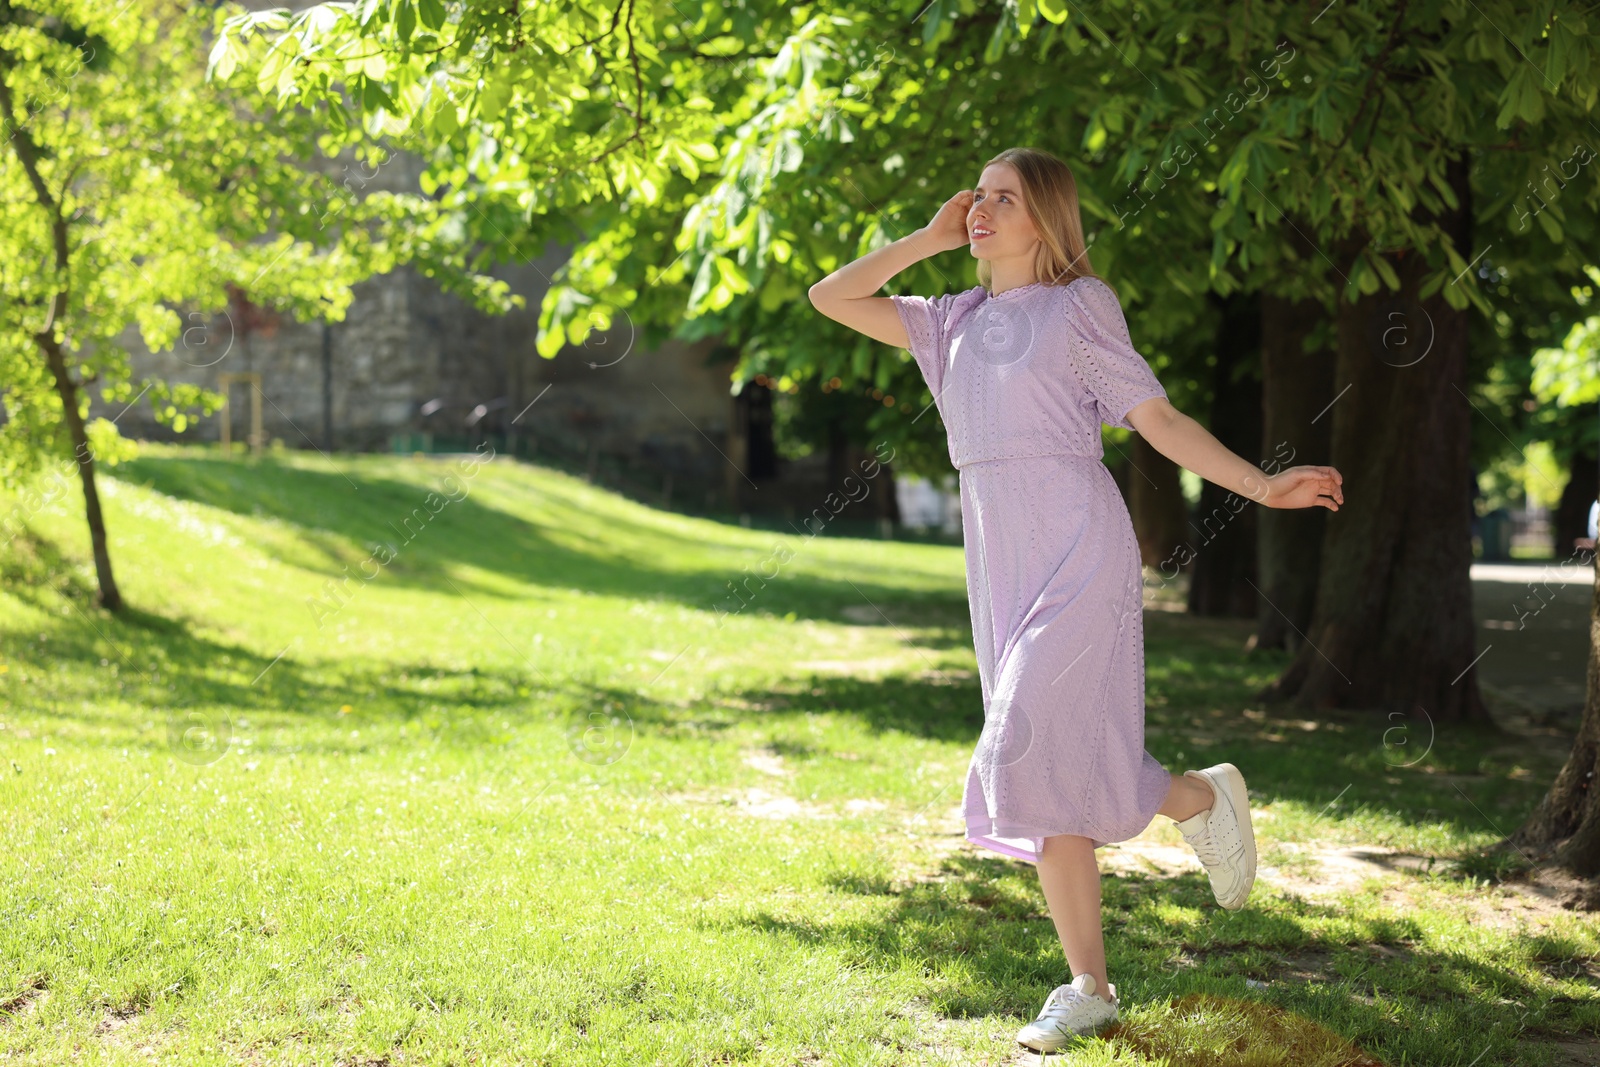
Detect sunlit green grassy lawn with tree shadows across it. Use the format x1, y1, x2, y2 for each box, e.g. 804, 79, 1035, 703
0, 446, 1600, 1067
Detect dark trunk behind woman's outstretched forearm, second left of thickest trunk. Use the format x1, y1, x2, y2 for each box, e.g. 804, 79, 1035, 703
1189, 293, 1261, 619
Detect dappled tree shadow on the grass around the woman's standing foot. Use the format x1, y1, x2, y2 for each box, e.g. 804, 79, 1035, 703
732, 853, 1581, 1067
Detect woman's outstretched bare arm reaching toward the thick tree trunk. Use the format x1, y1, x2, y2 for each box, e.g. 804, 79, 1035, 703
1128, 397, 1344, 512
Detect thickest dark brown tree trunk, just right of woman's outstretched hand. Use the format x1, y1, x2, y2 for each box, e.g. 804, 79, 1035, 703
1262, 158, 1488, 721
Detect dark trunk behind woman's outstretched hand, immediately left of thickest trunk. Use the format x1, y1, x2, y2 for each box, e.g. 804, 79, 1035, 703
1254, 283, 1334, 653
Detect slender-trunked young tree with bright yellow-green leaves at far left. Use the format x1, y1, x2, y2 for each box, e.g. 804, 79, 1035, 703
0, 0, 507, 611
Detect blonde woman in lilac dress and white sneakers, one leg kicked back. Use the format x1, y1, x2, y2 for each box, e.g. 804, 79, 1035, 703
810, 149, 1344, 1051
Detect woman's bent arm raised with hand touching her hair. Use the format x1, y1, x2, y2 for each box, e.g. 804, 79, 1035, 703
808, 189, 973, 349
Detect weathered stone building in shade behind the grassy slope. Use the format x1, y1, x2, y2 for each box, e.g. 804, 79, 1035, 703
94, 143, 949, 531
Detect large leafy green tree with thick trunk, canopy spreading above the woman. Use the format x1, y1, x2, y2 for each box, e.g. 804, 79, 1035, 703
213, 0, 1600, 718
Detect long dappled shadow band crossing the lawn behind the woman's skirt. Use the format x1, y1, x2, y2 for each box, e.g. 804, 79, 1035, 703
0, 579, 1544, 863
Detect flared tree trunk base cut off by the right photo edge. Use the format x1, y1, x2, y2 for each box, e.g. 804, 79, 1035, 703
1510, 524, 1600, 877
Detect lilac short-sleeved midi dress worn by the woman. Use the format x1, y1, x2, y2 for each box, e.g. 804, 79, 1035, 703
890, 277, 1171, 864
